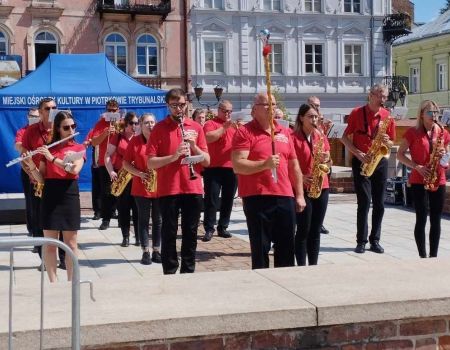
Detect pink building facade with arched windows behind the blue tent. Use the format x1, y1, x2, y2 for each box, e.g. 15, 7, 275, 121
0, 0, 188, 89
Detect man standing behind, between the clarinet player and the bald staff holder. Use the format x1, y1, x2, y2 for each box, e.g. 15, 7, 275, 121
202, 100, 237, 242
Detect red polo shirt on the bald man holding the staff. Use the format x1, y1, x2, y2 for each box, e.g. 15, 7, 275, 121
232, 120, 296, 197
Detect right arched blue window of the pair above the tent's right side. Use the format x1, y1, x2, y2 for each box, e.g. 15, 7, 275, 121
136, 34, 158, 75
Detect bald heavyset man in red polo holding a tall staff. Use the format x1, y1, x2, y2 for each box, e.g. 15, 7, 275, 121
231, 93, 306, 269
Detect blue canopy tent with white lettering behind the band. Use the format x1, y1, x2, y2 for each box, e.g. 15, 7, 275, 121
0, 53, 167, 193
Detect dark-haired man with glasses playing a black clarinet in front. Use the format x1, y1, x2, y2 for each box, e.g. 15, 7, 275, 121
146, 89, 209, 274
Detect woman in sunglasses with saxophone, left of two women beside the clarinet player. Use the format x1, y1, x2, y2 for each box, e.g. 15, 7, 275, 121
105, 112, 140, 247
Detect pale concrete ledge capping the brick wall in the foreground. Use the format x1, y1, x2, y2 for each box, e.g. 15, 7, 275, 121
0, 259, 450, 349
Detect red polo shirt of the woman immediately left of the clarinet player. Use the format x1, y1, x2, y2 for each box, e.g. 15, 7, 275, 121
123, 134, 156, 198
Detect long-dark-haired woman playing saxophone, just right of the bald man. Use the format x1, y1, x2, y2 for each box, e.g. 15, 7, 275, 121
292, 104, 331, 266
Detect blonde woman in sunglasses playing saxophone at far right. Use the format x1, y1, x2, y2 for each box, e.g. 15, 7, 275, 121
397, 100, 450, 258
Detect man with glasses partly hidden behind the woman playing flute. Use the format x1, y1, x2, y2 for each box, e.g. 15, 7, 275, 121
21, 97, 65, 268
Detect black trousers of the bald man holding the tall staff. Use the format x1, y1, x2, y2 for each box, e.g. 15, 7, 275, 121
242, 195, 295, 269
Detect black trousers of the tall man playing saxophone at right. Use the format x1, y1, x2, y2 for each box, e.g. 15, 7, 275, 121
352, 157, 388, 244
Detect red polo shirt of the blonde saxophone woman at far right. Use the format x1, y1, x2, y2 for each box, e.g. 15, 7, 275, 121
403, 127, 450, 185
